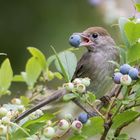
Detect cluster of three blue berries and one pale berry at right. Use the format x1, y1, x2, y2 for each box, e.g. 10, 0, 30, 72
113, 64, 140, 86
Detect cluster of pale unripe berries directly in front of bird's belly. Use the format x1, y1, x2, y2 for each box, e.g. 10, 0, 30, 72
63, 77, 90, 93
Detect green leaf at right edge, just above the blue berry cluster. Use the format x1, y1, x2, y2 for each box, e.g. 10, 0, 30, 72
127, 43, 140, 63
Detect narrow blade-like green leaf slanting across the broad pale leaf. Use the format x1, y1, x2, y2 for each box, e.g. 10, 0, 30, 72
52, 47, 70, 82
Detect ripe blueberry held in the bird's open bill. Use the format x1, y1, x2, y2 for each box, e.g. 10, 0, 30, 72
69, 34, 81, 47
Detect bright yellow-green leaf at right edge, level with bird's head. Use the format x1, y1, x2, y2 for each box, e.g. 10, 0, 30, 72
124, 21, 140, 45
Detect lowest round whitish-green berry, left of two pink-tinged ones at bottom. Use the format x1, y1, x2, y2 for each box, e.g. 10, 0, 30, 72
43, 127, 55, 138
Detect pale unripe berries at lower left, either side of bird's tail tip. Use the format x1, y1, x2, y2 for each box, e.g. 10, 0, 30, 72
0, 98, 43, 136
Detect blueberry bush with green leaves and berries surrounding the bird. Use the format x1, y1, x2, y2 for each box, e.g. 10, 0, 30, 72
0, 3, 140, 140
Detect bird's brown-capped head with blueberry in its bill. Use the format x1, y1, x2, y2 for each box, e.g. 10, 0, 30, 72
69, 27, 115, 51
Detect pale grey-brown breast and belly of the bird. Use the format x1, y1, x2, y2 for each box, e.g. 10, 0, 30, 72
85, 52, 117, 97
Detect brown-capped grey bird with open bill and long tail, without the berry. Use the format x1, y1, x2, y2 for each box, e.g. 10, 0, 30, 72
15, 27, 119, 122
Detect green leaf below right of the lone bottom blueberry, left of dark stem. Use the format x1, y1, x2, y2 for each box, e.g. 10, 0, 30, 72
82, 117, 104, 137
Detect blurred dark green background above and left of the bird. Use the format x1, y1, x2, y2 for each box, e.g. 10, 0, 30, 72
0, 0, 122, 74
